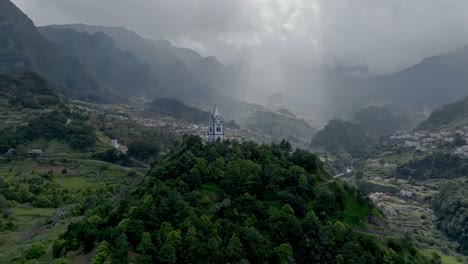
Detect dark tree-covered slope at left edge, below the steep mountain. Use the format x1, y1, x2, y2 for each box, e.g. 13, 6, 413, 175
0, 73, 96, 154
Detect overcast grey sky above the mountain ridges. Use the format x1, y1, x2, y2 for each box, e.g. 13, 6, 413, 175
13, 0, 468, 73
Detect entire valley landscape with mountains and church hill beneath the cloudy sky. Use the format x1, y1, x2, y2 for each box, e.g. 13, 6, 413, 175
0, 0, 468, 264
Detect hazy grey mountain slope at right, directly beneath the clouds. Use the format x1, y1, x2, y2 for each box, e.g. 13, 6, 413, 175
312, 45, 468, 118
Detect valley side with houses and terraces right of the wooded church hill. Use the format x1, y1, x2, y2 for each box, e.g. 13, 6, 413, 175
326, 102, 468, 263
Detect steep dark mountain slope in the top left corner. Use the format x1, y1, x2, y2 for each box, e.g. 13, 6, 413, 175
0, 0, 99, 99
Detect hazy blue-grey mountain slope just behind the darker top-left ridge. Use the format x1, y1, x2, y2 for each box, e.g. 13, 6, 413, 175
39, 27, 156, 96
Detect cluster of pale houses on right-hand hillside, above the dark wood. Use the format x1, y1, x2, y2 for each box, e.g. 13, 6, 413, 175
390, 126, 468, 154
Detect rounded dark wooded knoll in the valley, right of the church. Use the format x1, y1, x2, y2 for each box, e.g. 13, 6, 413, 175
311, 119, 375, 157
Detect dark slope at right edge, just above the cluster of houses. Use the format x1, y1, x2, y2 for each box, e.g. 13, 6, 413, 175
416, 97, 468, 130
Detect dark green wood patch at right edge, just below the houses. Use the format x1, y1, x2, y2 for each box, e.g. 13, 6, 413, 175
396, 152, 468, 180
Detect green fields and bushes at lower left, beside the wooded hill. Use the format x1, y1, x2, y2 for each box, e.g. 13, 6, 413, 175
0, 158, 141, 264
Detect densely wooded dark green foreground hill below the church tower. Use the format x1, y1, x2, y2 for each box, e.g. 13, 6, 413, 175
53, 136, 428, 263
